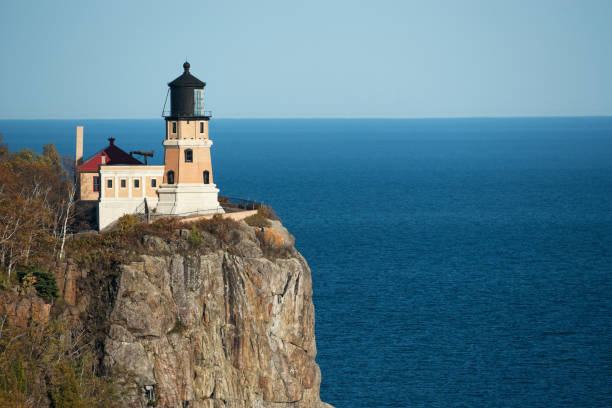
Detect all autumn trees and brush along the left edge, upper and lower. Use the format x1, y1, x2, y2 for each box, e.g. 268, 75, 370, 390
0, 140, 116, 408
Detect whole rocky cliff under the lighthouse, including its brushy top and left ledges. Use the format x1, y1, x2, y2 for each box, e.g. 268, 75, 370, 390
5, 215, 330, 408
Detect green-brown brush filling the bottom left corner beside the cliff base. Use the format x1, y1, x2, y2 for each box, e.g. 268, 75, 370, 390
0, 319, 117, 408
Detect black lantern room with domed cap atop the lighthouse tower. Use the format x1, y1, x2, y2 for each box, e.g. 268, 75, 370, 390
163, 61, 211, 120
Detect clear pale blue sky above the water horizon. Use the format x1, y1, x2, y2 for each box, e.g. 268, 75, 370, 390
0, 0, 612, 118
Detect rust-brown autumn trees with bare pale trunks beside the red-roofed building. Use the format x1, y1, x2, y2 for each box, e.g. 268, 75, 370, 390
0, 135, 75, 279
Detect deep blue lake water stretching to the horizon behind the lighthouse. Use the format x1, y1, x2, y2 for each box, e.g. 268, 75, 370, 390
0, 118, 612, 408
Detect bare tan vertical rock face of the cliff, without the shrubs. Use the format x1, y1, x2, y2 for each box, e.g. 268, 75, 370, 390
98, 221, 328, 408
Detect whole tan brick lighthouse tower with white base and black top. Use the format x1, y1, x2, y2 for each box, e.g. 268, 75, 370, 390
156, 62, 223, 215
